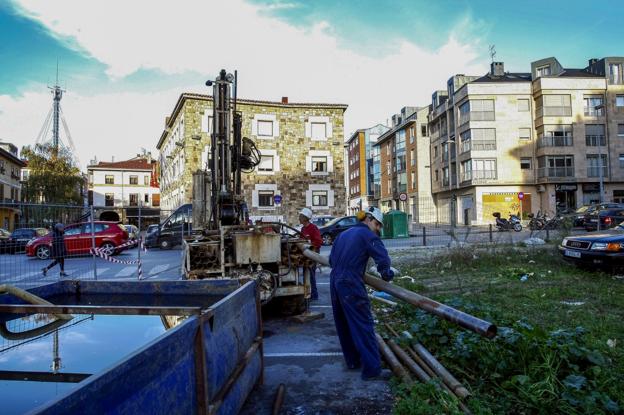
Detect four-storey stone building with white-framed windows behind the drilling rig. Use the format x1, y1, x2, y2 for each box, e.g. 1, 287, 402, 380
157, 93, 347, 228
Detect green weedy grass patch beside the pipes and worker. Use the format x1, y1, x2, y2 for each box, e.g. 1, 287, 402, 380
382, 246, 624, 414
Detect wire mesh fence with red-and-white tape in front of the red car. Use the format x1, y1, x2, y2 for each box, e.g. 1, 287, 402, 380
0, 203, 182, 287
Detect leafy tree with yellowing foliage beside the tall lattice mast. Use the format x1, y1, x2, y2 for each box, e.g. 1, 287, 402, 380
22, 144, 83, 205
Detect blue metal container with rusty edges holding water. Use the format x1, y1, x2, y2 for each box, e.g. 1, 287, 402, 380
0, 280, 263, 414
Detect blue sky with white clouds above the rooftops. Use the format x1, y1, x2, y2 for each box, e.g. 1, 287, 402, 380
0, 0, 624, 168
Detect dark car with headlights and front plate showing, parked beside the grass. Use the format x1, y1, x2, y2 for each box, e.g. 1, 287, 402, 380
559, 225, 624, 269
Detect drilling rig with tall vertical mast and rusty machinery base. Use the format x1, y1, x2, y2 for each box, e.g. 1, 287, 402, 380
185, 70, 310, 314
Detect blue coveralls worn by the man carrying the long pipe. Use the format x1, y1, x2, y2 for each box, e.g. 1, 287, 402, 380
329, 223, 394, 378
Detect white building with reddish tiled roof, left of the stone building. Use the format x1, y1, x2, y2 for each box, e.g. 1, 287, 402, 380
87, 153, 160, 226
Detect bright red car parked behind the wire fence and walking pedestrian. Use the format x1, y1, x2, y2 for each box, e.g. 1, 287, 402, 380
26, 221, 128, 259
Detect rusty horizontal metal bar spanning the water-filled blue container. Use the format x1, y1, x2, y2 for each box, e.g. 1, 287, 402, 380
0, 304, 204, 316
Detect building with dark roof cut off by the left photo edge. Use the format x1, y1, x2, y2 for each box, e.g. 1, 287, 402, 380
0, 142, 26, 231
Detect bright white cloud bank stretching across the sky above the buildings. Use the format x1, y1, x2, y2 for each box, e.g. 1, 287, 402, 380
0, 0, 486, 164
